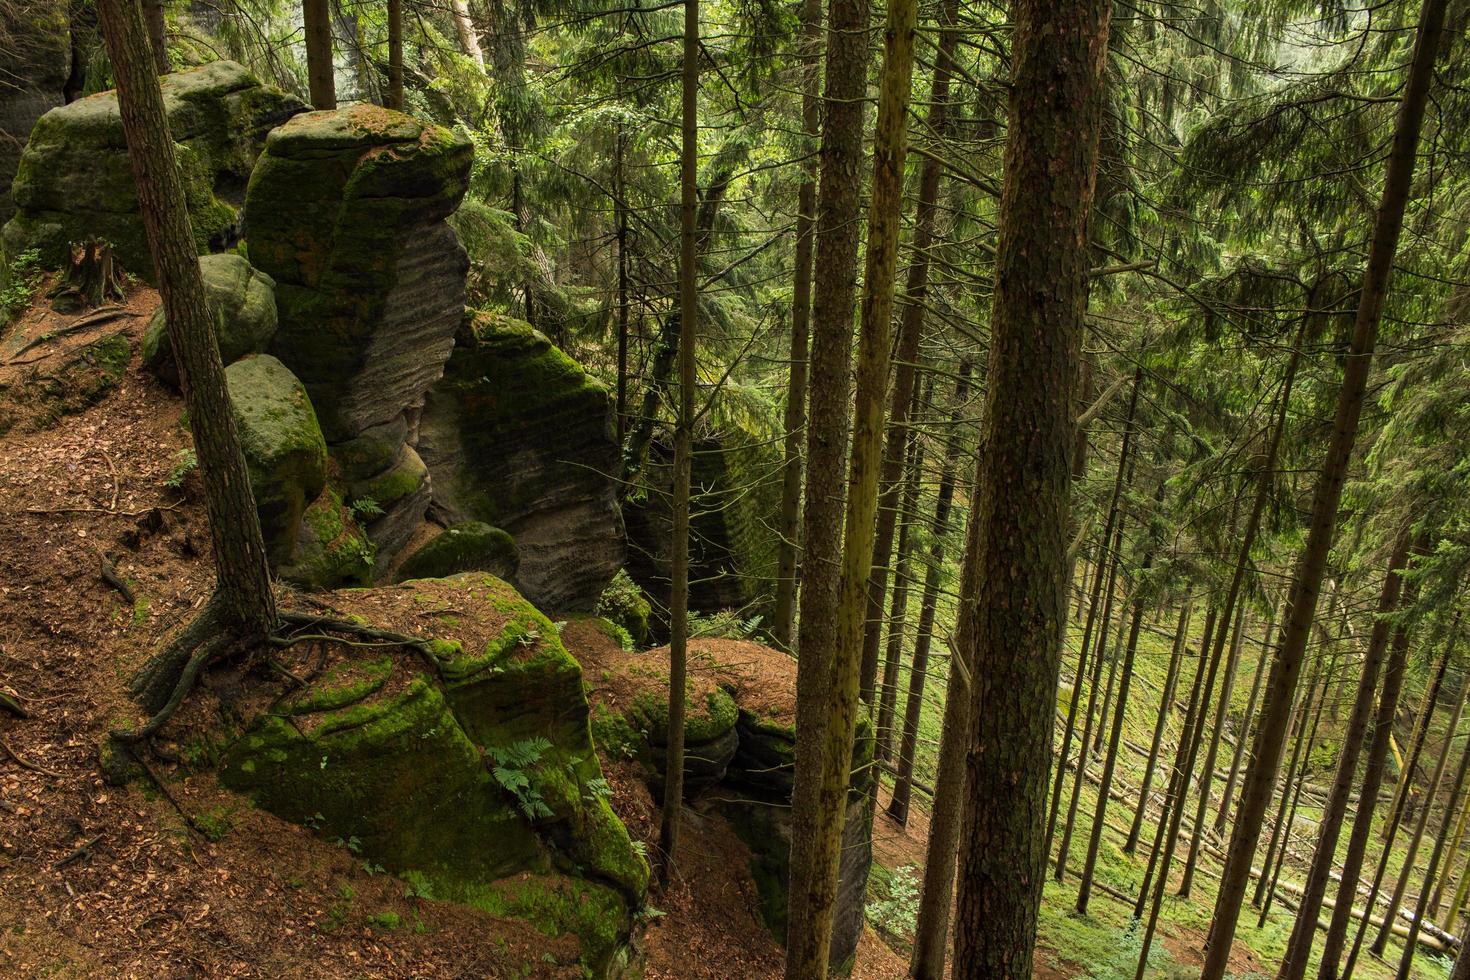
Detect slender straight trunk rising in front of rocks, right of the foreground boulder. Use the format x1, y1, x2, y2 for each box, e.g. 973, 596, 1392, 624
659, 0, 700, 887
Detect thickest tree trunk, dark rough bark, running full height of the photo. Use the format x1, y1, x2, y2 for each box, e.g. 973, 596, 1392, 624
954, 0, 1110, 980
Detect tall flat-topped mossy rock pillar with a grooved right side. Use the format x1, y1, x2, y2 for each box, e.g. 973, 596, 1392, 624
243, 104, 473, 445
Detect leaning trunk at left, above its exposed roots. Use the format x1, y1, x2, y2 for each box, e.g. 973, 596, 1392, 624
97, 0, 276, 641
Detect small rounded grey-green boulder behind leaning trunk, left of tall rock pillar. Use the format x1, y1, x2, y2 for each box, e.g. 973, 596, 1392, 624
141, 251, 276, 388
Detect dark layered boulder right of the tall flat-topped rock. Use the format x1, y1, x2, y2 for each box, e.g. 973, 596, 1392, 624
419, 317, 623, 613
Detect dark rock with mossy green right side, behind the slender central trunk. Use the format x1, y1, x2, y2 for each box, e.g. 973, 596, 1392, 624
623, 430, 782, 628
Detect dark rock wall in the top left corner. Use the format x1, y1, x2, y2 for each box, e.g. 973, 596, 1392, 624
0, 1, 72, 223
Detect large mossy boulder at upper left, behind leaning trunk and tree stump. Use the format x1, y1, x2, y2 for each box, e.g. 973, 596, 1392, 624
3, 62, 304, 281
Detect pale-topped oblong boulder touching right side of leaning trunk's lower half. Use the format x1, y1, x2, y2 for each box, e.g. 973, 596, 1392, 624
225, 354, 326, 564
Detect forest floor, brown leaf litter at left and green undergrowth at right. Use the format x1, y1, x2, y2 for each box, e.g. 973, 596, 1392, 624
0, 279, 1441, 980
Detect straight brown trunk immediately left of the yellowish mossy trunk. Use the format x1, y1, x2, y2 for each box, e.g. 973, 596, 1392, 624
786, 0, 882, 957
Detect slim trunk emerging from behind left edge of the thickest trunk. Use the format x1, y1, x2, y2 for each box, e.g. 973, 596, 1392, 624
908, 481, 980, 980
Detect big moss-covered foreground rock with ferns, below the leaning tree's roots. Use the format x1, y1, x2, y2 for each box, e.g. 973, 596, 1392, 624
221, 573, 648, 977
